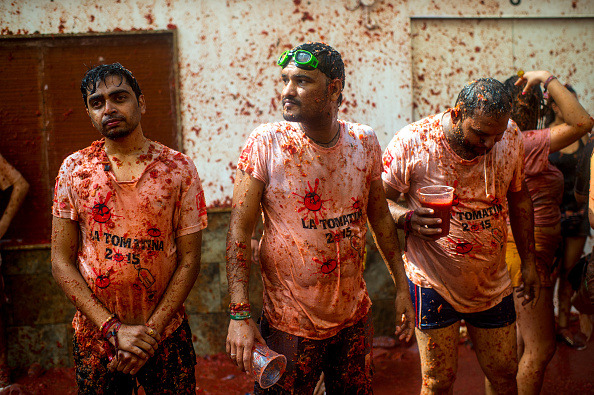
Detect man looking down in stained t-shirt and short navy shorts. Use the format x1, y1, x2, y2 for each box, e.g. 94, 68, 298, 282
382, 78, 539, 394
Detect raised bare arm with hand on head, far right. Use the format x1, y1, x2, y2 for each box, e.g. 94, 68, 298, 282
516, 70, 594, 153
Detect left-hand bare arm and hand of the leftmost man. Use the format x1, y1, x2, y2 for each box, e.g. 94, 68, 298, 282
51, 217, 158, 373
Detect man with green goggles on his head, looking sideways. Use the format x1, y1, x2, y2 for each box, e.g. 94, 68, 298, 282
227, 43, 414, 394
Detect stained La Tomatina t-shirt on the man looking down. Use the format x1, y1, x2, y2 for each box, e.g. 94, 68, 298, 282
382, 113, 524, 313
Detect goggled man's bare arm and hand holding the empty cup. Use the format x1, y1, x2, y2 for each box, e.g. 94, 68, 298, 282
226, 170, 265, 372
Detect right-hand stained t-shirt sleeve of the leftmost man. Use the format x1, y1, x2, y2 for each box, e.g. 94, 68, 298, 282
175, 158, 208, 237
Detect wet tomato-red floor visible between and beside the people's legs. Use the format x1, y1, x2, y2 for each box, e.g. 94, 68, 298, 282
0, 332, 594, 395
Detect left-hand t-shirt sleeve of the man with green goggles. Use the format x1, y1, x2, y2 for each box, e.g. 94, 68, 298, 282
237, 125, 270, 184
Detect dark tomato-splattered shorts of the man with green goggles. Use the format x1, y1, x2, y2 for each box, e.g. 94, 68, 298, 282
254, 313, 373, 394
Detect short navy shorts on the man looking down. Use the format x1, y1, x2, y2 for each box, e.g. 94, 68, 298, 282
408, 280, 516, 330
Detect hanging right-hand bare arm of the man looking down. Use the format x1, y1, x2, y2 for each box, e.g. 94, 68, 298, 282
507, 181, 540, 306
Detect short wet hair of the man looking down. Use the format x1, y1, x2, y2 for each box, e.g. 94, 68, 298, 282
456, 78, 512, 117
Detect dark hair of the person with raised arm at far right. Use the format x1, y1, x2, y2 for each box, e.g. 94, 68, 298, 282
503, 75, 546, 130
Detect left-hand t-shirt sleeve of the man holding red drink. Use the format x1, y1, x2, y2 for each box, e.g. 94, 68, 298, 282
382, 132, 412, 193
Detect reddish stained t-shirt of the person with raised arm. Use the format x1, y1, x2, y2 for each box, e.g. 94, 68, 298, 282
522, 128, 563, 226
